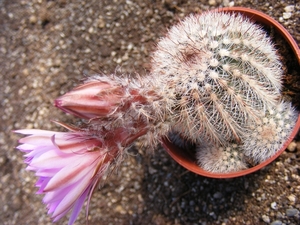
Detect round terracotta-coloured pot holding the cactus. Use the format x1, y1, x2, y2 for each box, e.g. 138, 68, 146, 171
162, 7, 300, 178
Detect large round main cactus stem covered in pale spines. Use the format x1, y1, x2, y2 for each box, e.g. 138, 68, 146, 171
152, 12, 282, 144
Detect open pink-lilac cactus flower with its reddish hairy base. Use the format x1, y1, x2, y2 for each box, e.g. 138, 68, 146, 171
15, 124, 148, 225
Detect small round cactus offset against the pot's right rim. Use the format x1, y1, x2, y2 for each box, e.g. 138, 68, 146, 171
242, 102, 298, 163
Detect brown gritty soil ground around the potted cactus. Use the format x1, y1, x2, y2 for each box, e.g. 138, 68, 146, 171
0, 0, 300, 225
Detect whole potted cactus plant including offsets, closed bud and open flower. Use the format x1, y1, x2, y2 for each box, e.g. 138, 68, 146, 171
16, 12, 297, 224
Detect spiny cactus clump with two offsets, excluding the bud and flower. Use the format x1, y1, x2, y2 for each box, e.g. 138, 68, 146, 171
152, 12, 298, 173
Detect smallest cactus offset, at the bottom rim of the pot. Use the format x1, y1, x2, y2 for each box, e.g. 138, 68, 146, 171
196, 143, 247, 173
